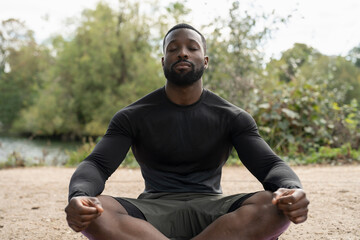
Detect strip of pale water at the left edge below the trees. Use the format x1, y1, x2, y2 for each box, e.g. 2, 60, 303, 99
0, 136, 80, 166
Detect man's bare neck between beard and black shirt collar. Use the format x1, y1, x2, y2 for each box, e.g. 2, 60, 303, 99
165, 79, 203, 105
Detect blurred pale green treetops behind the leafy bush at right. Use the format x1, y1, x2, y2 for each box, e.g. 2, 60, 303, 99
264, 43, 360, 104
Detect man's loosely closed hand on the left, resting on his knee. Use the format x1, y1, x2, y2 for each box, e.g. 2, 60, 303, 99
65, 196, 104, 232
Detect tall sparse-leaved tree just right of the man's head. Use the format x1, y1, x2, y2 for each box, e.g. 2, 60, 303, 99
205, 1, 285, 109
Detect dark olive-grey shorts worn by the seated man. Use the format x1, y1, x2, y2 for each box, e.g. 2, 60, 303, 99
115, 193, 254, 240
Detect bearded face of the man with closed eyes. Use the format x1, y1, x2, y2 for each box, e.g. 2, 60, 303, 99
161, 28, 208, 86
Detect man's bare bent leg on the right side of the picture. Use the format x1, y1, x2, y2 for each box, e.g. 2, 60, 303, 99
193, 191, 290, 240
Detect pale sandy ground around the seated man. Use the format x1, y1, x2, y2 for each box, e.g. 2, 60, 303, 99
0, 165, 360, 240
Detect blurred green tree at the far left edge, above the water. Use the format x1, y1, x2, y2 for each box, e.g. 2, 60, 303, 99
0, 19, 52, 131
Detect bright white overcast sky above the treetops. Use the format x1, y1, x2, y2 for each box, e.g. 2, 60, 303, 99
0, 0, 360, 57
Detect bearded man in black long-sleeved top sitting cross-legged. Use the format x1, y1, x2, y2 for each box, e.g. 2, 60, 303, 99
65, 24, 309, 240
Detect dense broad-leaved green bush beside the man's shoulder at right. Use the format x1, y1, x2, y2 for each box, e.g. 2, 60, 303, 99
253, 81, 360, 154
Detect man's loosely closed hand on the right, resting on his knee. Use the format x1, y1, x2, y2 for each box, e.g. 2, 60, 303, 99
272, 188, 310, 224
